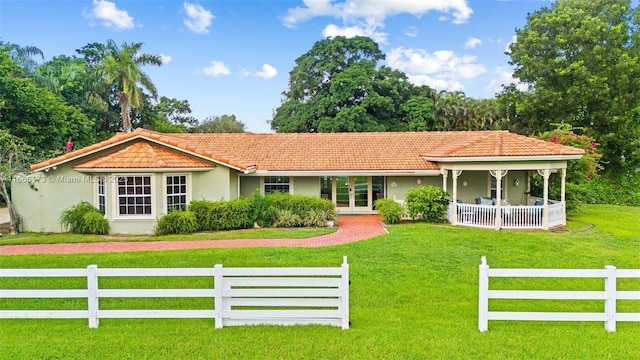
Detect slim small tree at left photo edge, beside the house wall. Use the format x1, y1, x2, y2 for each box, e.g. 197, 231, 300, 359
0, 129, 33, 235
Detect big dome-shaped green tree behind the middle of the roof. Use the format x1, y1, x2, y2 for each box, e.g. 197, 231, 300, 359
271, 36, 429, 132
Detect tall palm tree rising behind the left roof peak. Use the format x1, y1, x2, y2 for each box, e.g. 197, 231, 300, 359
95, 40, 162, 132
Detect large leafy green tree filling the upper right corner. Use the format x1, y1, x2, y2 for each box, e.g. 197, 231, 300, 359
509, 0, 640, 174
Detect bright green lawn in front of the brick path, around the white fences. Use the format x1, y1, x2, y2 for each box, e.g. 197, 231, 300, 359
0, 205, 640, 359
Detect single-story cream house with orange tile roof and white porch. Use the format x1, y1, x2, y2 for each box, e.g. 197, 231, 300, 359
12, 129, 583, 234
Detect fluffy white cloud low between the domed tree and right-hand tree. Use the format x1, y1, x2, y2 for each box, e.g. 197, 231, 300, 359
387, 47, 487, 91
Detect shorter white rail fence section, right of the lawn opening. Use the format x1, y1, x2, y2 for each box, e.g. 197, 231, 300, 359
478, 256, 640, 332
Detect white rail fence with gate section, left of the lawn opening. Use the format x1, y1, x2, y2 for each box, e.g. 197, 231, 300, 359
0, 256, 349, 329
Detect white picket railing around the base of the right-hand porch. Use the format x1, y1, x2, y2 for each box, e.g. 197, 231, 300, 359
447, 202, 565, 229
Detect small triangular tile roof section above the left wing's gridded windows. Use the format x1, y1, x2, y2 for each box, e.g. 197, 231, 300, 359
73, 140, 215, 169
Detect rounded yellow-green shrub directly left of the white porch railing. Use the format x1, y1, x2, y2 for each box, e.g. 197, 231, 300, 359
405, 186, 449, 223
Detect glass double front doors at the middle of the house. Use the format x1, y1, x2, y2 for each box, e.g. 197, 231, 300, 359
334, 176, 371, 212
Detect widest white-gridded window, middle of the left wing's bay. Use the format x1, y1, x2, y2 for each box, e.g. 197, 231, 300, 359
117, 175, 152, 216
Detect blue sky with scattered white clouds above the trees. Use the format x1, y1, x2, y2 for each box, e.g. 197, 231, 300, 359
0, 0, 550, 132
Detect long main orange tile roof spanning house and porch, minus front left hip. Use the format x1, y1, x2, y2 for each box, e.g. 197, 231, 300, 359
31, 129, 583, 171
